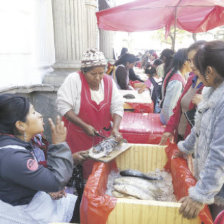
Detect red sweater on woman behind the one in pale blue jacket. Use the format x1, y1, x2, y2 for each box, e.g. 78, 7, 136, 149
164, 74, 204, 141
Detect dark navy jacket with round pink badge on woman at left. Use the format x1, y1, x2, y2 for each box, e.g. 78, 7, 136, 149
0, 135, 73, 205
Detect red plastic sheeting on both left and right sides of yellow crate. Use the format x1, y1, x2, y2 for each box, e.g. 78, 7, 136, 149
80, 144, 213, 224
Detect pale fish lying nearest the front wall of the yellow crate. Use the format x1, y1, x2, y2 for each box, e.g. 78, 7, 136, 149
114, 184, 154, 200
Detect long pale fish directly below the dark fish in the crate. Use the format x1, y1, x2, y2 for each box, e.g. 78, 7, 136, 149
114, 177, 161, 196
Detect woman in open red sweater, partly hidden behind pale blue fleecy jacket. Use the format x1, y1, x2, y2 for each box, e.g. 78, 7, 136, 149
160, 41, 205, 144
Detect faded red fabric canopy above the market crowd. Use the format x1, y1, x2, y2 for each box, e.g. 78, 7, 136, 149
96, 0, 224, 33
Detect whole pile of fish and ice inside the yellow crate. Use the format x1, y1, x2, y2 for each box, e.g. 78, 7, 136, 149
106, 170, 175, 201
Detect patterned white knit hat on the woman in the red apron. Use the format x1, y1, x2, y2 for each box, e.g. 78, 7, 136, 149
81, 49, 107, 68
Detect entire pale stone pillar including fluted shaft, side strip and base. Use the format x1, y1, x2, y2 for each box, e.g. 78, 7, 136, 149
43, 0, 98, 86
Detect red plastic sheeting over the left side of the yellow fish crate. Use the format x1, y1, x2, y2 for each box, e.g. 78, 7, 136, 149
80, 162, 117, 224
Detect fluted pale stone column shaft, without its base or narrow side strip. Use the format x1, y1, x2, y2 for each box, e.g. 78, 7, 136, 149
52, 0, 87, 68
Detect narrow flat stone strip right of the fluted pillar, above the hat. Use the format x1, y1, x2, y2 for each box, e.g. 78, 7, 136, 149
85, 0, 98, 48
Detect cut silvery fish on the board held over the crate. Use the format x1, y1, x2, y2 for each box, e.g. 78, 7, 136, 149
89, 137, 125, 159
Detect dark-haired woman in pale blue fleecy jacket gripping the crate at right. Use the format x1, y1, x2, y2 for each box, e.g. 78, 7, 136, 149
176, 41, 224, 219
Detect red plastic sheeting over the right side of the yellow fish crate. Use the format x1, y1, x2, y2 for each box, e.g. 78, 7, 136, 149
165, 143, 213, 224
